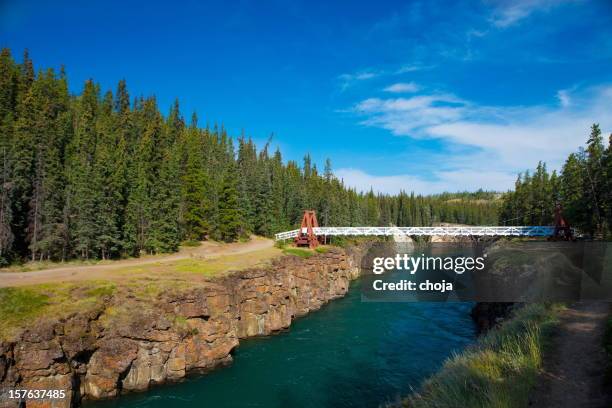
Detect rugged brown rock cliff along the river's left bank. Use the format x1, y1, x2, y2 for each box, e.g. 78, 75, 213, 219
0, 249, 361, 407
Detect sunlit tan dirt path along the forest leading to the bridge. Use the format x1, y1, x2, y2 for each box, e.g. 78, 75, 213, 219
0, 237, 274, 287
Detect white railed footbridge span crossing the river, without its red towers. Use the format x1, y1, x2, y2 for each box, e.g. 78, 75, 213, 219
275, 226, 555, 241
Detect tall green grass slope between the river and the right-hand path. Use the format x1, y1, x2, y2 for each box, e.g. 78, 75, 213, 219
400, 304, 559, 408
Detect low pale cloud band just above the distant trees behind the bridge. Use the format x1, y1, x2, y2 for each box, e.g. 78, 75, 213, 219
335, 168, 516, 194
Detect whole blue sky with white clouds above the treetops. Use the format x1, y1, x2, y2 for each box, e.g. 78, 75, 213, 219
0, 0, 612, 193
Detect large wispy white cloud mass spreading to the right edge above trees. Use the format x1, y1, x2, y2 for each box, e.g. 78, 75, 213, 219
347, 86, 612, 191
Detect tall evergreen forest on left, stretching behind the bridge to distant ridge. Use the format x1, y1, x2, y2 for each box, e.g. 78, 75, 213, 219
0, 49, 499, 263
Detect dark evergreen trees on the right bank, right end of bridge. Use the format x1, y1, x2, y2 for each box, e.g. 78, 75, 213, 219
500, 124, 612, 238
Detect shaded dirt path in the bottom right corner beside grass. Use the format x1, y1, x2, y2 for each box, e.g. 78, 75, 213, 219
530, 303, 612, 408
